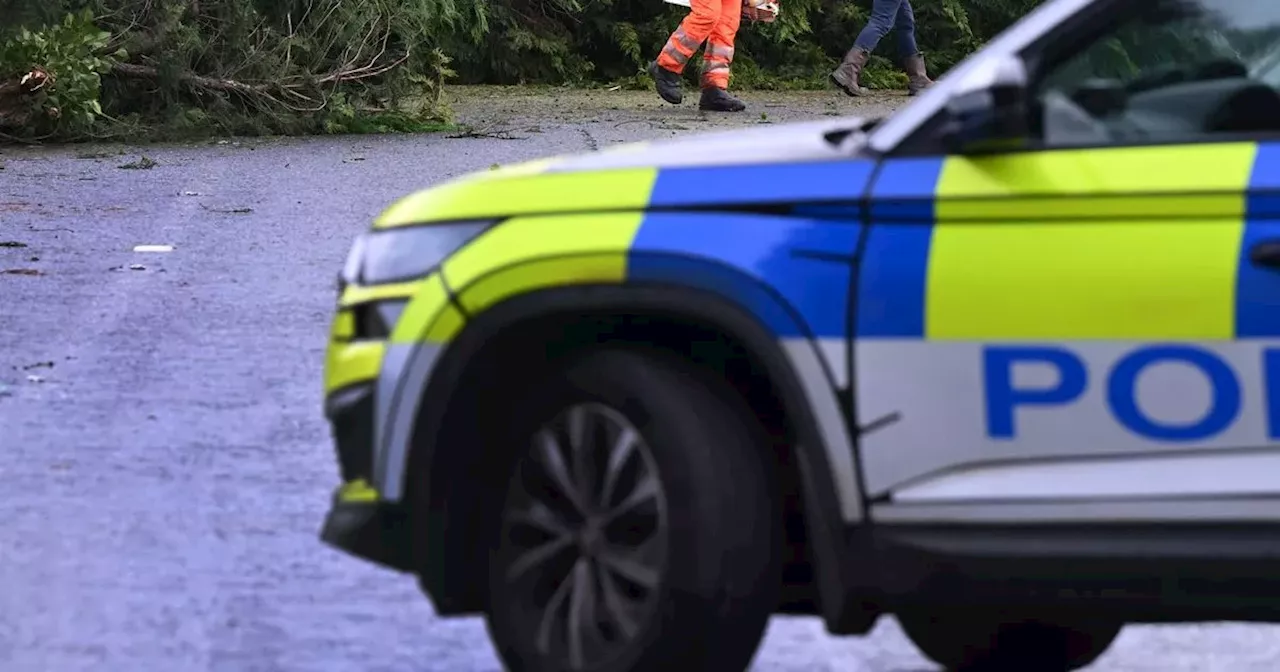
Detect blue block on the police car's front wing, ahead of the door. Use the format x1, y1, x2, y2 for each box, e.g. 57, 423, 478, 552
627, 161, 874, 338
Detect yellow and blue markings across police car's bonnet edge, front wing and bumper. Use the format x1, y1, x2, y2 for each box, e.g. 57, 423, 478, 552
325, 160, 874, 392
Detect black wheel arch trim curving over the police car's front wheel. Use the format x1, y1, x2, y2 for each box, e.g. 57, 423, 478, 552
403, 284, 880, 631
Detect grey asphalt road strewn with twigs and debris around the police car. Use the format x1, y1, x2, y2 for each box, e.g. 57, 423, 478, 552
0, 90, 1280, 672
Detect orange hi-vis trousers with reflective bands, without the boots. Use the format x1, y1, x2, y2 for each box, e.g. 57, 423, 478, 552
658, 0, 742, 88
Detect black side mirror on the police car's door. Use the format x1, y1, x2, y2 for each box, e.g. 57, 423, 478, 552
942, 58, 1030, 154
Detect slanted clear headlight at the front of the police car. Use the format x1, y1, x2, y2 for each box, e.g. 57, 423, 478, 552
342, 220, 493, 284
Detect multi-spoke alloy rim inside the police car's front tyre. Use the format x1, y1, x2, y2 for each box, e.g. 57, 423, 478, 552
500, 403, 668, 669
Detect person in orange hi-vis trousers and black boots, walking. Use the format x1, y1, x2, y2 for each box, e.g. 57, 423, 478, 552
649, 0, 746, 111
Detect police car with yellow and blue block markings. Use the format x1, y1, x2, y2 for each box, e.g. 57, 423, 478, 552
323, 0, 1280, 672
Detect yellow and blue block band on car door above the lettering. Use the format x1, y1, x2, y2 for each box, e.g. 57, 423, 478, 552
856, 143, 1280, 340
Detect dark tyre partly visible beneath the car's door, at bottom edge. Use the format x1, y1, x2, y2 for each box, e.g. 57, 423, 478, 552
897, 609, 1123, 672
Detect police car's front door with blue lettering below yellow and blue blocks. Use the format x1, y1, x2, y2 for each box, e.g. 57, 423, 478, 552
854, 0, 1280, 521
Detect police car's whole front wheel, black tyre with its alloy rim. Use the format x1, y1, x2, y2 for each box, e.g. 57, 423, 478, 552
486, 349, 782, 672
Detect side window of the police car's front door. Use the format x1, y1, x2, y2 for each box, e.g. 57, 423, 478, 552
1033, 0, 1280, 146
